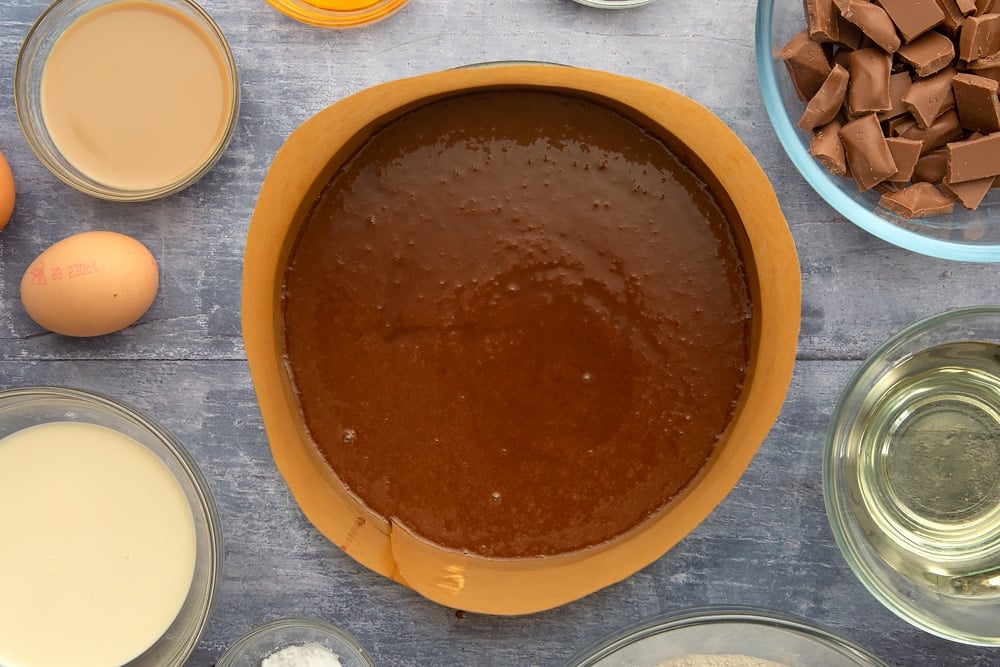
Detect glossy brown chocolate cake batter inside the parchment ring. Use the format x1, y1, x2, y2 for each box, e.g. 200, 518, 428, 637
284, 89, 751, 557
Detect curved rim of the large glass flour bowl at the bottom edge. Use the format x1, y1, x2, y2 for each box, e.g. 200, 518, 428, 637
566, 604, 887, 667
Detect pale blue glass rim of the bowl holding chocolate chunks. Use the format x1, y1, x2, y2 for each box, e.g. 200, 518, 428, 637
754, 0, 1000, 262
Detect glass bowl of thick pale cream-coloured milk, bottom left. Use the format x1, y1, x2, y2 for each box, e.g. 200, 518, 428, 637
0, 387, 222, 667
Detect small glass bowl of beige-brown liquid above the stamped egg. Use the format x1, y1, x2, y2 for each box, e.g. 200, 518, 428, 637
14, 0, 240, 201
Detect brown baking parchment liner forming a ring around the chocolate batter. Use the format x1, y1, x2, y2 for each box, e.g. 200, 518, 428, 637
242, 64, 800, 614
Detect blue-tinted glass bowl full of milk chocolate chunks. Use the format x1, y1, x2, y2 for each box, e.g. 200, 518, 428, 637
756, 0, 1000, 262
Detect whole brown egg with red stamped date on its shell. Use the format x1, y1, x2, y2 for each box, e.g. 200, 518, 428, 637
21, 231, 159, 336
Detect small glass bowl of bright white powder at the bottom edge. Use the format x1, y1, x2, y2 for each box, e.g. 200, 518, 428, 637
216, 618, 375, 667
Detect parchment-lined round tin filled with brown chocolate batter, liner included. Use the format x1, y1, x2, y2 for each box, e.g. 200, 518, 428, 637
242, 63, 800, 614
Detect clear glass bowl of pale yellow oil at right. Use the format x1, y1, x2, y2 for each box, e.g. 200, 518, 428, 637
823, 307, 1000, 646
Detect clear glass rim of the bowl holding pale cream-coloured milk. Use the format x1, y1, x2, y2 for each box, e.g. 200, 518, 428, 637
0, 385, 224, 666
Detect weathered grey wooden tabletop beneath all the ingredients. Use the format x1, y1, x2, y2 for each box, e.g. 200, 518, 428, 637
0, 0, 1000, 666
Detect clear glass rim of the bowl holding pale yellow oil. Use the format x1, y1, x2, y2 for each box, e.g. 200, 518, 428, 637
822, 306, 1000, 647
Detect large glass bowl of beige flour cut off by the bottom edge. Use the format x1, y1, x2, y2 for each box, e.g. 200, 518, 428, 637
567, 606, 886, 667
